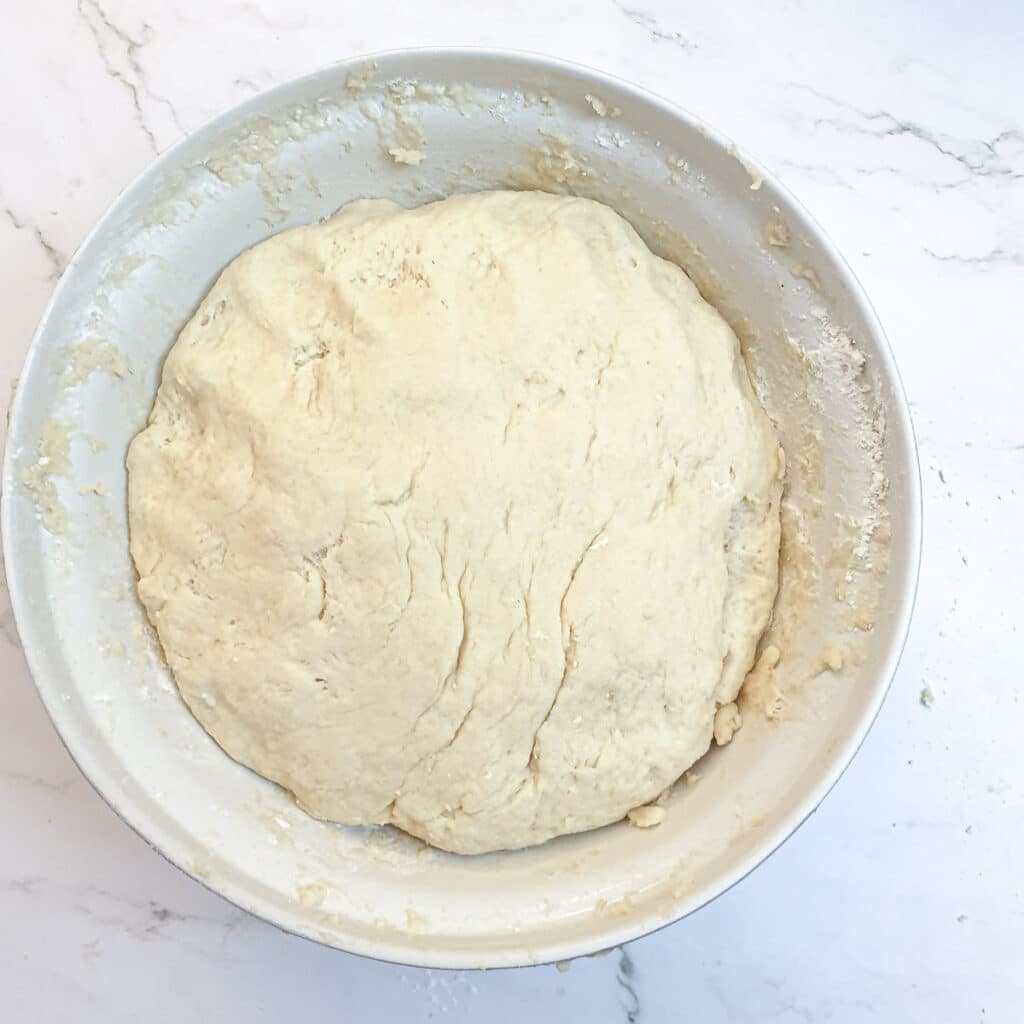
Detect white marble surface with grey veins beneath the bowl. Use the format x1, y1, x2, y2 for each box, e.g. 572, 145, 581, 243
0, 0, 1024, 1024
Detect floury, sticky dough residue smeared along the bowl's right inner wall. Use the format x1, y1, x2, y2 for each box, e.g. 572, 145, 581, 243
650, 219, 891, 721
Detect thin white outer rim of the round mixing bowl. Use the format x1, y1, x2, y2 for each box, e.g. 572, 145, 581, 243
0, 45, 924, 970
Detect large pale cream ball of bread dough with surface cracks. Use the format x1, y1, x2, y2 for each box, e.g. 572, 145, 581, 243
128, 191, 781, 853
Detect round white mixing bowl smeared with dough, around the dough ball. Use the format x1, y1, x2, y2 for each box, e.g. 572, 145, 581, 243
3, 49, 921, 968
